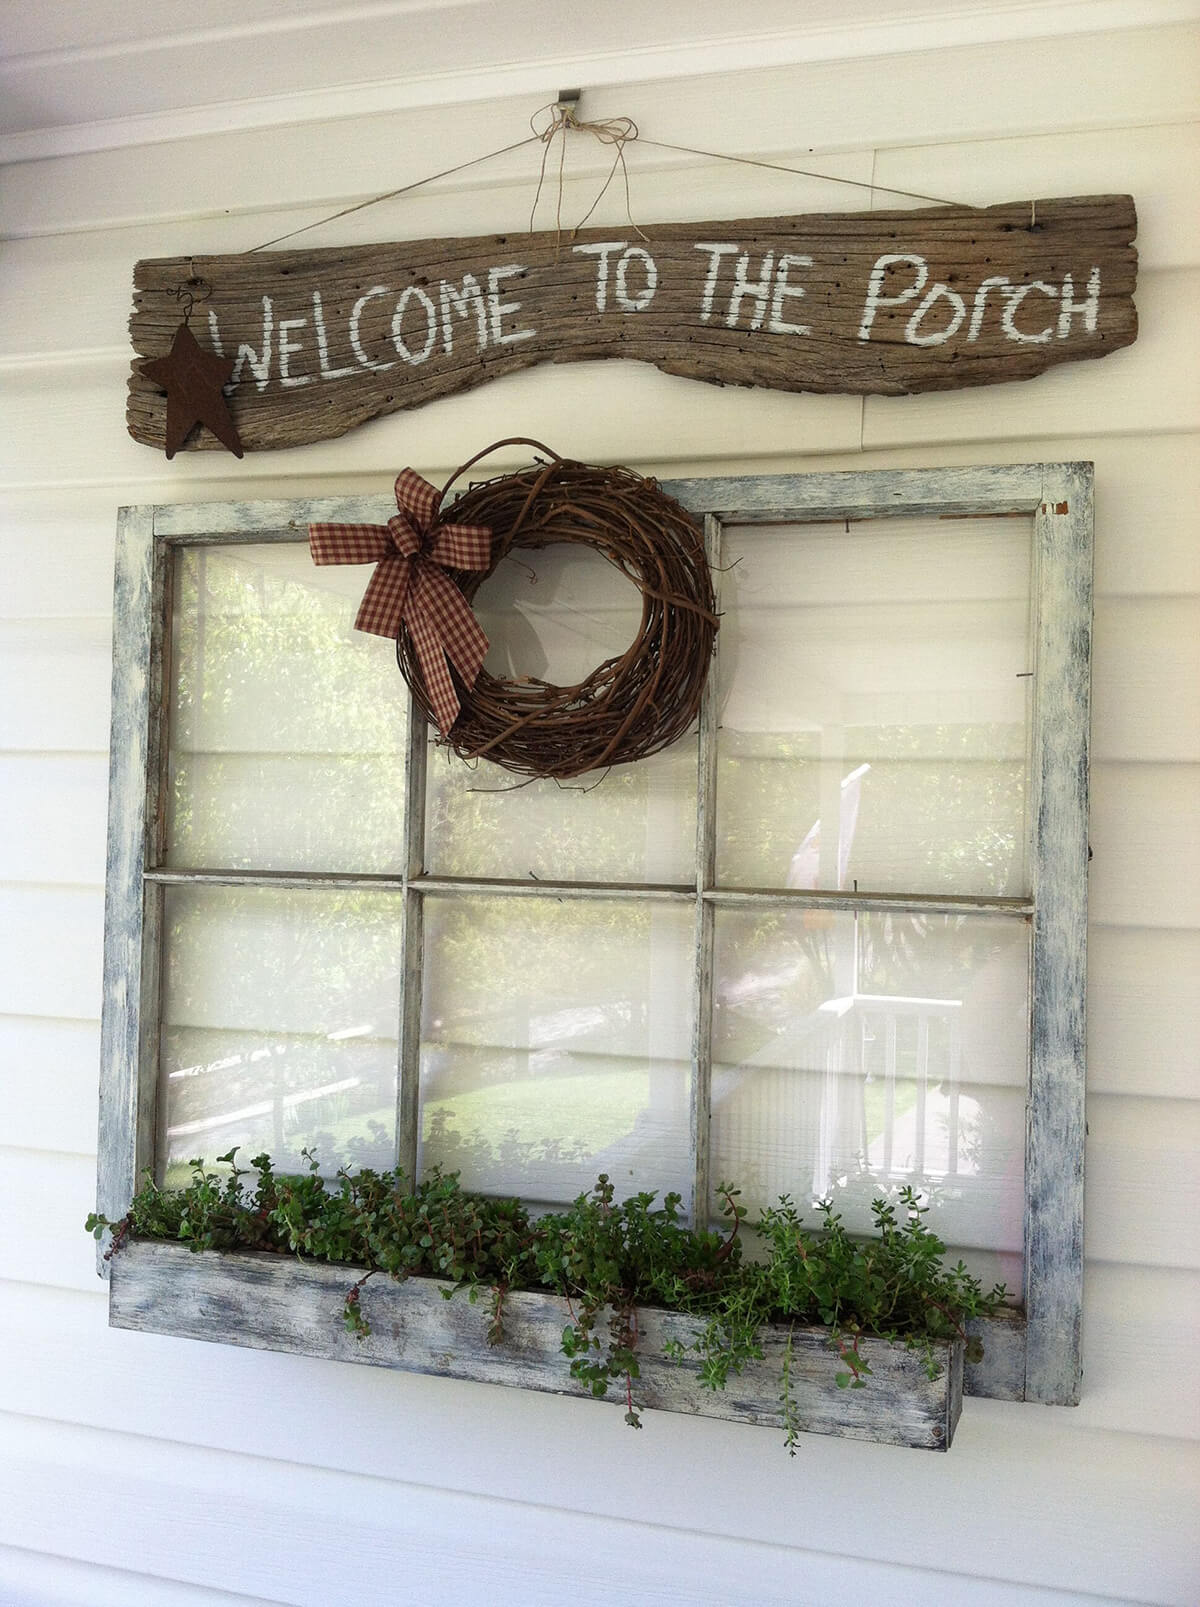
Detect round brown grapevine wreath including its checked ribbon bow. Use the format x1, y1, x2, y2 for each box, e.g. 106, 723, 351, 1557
310, 439, 718, 781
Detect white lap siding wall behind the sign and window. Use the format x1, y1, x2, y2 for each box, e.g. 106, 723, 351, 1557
0, 27, 1200, 1607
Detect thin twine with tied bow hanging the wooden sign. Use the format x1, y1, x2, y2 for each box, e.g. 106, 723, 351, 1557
246, 101, 963, 256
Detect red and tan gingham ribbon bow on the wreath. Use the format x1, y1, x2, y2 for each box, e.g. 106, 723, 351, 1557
308, 469, 492, 736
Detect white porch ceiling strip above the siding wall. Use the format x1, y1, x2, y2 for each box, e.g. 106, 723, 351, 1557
0, 0, 1200, 161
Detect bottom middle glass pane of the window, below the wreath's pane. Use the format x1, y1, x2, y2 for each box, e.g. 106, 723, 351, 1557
421, 897, 694, 1204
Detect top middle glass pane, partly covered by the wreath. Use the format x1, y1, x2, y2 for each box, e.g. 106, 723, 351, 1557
426, 546, 696, 884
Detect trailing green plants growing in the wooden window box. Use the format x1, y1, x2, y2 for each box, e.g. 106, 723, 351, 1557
87, 1149, 1006, 1450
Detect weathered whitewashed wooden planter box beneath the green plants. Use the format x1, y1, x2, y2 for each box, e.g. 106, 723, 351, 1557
109, 1241, 962, 1451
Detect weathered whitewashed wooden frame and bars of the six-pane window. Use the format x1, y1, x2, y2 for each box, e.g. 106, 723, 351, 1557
98, 463, 1092, 1405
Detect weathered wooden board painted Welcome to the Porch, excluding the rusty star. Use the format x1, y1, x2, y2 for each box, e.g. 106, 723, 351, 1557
129, 196, 1137, 450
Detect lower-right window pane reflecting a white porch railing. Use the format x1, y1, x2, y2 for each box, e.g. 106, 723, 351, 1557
712, 910, 1028, 1287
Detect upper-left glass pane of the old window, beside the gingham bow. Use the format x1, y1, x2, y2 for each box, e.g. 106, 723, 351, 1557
167, 543, 408, 871
